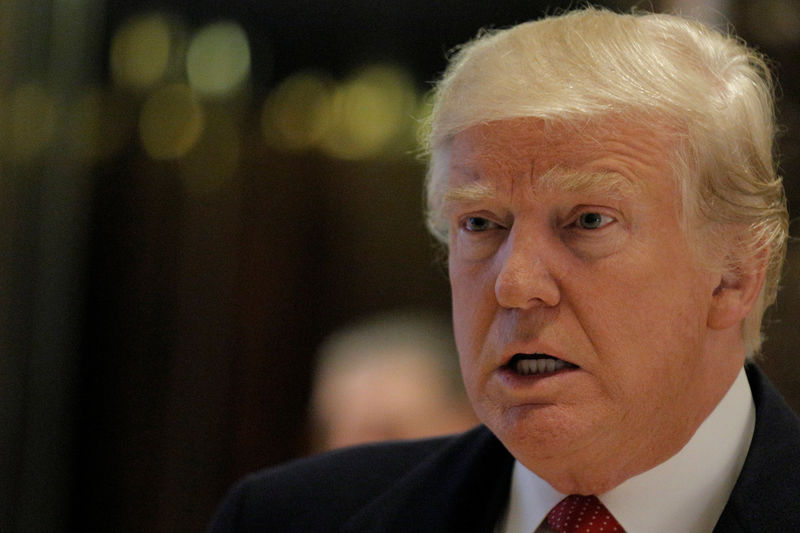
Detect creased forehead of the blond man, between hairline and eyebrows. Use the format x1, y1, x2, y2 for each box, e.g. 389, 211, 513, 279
445, 118, 673, 202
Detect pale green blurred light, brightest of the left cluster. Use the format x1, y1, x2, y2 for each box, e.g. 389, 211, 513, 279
186, 22, 250, 97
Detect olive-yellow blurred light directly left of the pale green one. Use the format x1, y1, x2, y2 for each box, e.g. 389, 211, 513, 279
109, 13, 174, 90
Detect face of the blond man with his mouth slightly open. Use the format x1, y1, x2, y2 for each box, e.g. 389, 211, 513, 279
445, 119, 742, 493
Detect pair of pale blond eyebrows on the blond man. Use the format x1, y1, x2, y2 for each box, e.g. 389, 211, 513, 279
444, 168, 639, 205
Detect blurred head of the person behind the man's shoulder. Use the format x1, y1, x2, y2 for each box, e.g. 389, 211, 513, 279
310, 311, 477, 451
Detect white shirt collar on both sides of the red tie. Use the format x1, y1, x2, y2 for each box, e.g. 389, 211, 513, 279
498, 368, 755, 533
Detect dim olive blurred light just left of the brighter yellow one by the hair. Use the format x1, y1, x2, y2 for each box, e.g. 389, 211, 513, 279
261, 71, 333, 150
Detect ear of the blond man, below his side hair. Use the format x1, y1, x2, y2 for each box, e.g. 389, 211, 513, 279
708, 253, 767, 329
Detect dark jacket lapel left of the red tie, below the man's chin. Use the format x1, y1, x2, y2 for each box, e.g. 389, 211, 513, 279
343, 426, 513, 533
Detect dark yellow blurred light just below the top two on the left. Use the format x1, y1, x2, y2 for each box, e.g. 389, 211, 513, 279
139, 83, 204, 159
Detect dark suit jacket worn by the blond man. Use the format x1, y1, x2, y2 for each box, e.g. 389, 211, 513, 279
211, 366, 800, 533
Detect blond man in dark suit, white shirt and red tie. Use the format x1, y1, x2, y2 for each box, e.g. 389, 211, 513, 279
212, 8, 800, 533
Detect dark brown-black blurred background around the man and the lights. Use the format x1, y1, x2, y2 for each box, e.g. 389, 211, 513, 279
0, 0, 800, 532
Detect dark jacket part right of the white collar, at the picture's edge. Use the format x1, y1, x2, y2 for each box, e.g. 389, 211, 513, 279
714, 365, 800, 533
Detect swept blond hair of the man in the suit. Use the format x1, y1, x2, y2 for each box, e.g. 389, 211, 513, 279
426, 8, 788, 356
